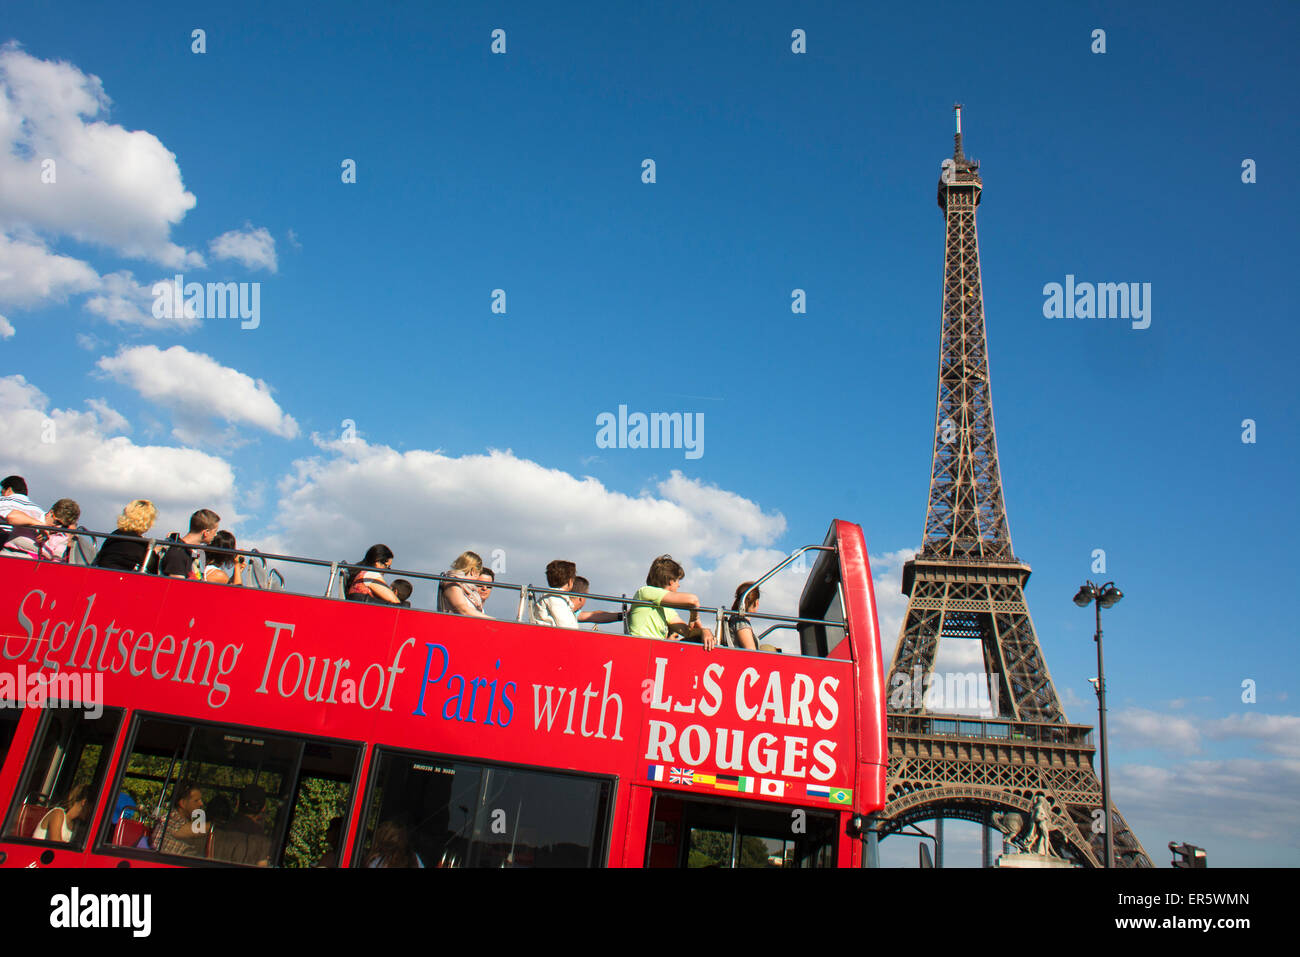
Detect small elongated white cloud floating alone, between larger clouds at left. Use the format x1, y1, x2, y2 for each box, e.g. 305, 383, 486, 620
98, 346, 298, 443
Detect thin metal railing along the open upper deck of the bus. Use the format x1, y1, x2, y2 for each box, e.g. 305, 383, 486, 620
0, 521, 846, 657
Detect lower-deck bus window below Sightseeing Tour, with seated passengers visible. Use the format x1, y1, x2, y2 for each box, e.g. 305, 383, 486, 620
109, 718, 360, 867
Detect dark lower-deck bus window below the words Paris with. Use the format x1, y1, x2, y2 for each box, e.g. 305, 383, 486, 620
354, 750, 614, 867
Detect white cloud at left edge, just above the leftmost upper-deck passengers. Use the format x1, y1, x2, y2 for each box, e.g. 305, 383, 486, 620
0, 376, 239, 534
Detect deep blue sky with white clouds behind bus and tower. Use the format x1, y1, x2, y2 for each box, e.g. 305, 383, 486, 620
0, 3, 1300, 866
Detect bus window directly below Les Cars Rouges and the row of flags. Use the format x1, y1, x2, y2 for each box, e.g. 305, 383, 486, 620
646, 793, 837, 867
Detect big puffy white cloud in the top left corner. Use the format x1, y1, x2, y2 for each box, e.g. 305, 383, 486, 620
0, 43, 203, 268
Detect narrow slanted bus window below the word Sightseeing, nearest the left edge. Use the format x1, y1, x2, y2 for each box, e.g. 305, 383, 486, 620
4, 707, 122, 850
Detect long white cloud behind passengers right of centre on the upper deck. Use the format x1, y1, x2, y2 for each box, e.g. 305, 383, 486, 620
259, 438, 790, 623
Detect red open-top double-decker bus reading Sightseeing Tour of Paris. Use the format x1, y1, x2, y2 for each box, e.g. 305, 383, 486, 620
0, 521, 887, 867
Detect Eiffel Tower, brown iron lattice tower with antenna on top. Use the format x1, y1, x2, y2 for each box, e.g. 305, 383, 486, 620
875, 105, 1151, 867
